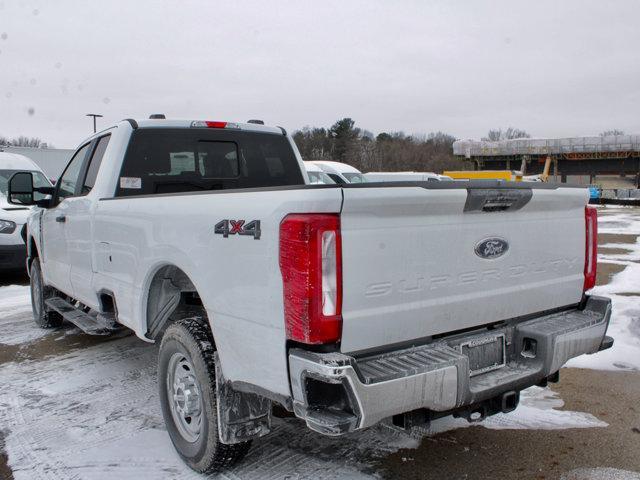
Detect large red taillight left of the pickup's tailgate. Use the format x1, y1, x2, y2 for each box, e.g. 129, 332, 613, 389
280, 213, 342, 344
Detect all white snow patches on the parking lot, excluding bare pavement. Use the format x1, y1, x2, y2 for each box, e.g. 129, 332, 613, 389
0, 204, 640, 480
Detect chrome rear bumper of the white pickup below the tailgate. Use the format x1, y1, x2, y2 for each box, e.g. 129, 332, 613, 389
289, 296, 611, 435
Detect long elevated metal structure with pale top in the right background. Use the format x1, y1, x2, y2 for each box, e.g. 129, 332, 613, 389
453, 135, 640, 188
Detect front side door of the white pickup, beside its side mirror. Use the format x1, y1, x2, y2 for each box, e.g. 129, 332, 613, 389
41, 143, 91, 295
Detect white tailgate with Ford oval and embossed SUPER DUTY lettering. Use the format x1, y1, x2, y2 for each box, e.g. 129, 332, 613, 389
341, 186, 588, 352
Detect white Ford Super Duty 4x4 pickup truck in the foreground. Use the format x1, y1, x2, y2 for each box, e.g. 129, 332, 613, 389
9, 119, 613, 472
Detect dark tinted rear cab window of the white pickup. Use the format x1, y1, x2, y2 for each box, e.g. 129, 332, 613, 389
116, 128, 304, 197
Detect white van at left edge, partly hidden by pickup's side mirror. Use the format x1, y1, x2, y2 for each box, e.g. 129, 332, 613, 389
0, 152, 51, 270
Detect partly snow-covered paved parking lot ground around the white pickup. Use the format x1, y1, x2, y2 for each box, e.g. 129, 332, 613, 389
0, 207, 640, 480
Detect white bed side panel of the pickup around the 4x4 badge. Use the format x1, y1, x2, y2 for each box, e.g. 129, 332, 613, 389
94, 187, 342, 395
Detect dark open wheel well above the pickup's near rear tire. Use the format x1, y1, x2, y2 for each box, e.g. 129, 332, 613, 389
147, 265, 213, 341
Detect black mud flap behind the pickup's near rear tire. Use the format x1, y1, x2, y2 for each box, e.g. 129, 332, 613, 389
214, 352, 272, 445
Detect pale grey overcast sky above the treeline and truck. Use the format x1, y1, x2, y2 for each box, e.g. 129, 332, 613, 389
0, 0, 640, 148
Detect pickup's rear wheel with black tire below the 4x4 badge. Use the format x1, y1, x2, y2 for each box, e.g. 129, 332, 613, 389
158, 319, 251, 473
